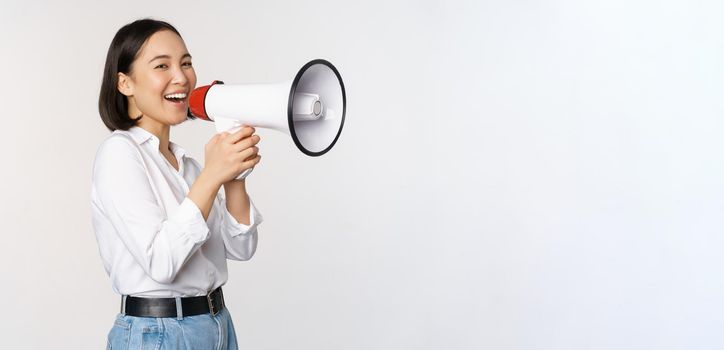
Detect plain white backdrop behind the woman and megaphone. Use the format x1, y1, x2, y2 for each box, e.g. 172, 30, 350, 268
0, 0, 724, 350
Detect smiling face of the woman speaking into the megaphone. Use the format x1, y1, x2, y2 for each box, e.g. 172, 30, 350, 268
118, 30, 196, 125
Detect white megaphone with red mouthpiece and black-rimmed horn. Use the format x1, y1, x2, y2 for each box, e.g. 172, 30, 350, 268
189, 59, 347, 179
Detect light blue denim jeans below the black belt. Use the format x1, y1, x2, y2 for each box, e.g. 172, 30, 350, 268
107, 308, 238, 350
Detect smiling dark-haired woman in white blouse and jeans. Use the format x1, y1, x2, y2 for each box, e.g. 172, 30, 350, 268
91, 19, 262, 349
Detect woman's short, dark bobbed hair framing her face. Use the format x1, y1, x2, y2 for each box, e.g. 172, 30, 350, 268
98, 18, 195, 131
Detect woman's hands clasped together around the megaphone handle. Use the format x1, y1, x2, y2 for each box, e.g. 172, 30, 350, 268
203, 126, 261, 185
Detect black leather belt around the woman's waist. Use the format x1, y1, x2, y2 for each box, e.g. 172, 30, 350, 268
121, 287, 226, 317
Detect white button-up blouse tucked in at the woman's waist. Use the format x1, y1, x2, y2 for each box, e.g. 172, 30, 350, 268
91, 126, 263, 297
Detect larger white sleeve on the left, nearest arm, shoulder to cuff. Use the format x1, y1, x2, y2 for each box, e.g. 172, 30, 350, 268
93, 137, 209, 284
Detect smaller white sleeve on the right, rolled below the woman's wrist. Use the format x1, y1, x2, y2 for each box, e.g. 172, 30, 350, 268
217, 195, 264, 261
